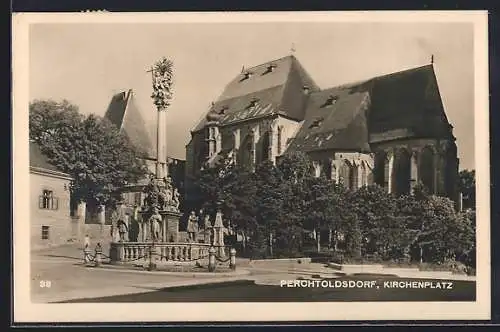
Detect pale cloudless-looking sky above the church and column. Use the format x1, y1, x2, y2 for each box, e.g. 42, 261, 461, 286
29, 22, 474, 169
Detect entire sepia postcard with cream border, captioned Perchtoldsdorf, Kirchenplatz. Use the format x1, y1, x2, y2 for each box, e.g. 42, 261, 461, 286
12, 11, 491, 323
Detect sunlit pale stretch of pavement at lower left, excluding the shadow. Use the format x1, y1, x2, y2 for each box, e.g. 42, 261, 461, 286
31, 245, 248, 302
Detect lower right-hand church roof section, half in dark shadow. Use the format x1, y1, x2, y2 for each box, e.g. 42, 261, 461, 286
287, 65, 452, 152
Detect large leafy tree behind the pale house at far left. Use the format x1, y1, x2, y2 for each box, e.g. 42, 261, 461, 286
29, 100, 147, 206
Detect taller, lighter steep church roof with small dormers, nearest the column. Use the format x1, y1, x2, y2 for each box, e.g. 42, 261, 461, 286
193, 56, 319, 132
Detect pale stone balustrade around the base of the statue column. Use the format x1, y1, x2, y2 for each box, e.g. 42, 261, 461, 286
110, 242, 215, 264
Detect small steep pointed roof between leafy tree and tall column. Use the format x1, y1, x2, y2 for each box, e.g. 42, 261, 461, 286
105, 90, 154, 157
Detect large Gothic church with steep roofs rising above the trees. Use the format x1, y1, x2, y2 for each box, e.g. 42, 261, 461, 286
186, 56, 458, 201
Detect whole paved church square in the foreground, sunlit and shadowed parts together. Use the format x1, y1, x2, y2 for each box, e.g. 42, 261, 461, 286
31, 245, 475, 303
